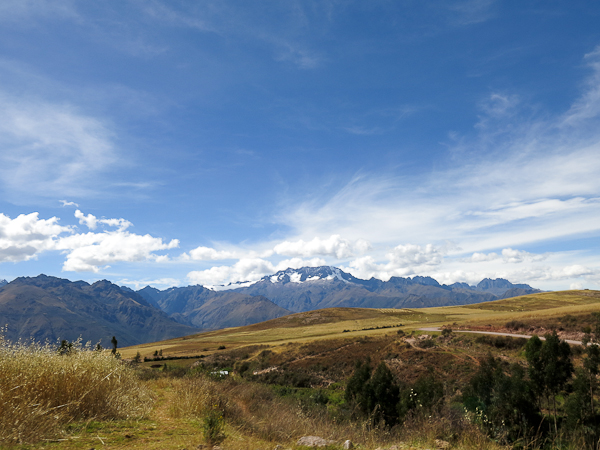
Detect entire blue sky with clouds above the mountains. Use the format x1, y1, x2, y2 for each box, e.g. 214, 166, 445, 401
0, 0, 600, 289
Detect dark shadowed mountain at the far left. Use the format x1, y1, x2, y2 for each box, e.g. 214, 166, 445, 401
0, 275, 199, 346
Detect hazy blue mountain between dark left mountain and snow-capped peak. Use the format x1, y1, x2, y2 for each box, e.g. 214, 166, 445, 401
138, 286, 290, 330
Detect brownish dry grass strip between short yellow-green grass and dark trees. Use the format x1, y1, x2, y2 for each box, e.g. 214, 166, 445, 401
171, 376, 500, 450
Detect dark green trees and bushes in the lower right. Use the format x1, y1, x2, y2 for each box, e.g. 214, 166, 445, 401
345, 322, 600, 450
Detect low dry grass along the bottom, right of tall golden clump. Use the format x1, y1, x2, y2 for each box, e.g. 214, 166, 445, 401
8, 376, 501, 450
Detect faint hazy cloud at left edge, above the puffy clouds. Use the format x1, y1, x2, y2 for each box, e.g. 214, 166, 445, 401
0, 93, 116, 199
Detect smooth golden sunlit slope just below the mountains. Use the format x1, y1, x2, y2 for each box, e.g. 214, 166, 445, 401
122, 291, 600, 357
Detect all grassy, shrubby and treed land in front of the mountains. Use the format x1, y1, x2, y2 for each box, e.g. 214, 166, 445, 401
0, 293, 600, 450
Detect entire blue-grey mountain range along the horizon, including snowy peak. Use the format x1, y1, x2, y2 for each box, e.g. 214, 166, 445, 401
0, 266, 541, 345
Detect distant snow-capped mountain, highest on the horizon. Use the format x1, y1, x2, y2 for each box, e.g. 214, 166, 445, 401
221, 266, 541, 312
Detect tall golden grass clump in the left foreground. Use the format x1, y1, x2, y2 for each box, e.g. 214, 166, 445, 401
0, 329, 152, 444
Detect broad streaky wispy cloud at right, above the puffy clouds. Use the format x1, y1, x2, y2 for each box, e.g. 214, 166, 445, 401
279, 50, 600, 272
